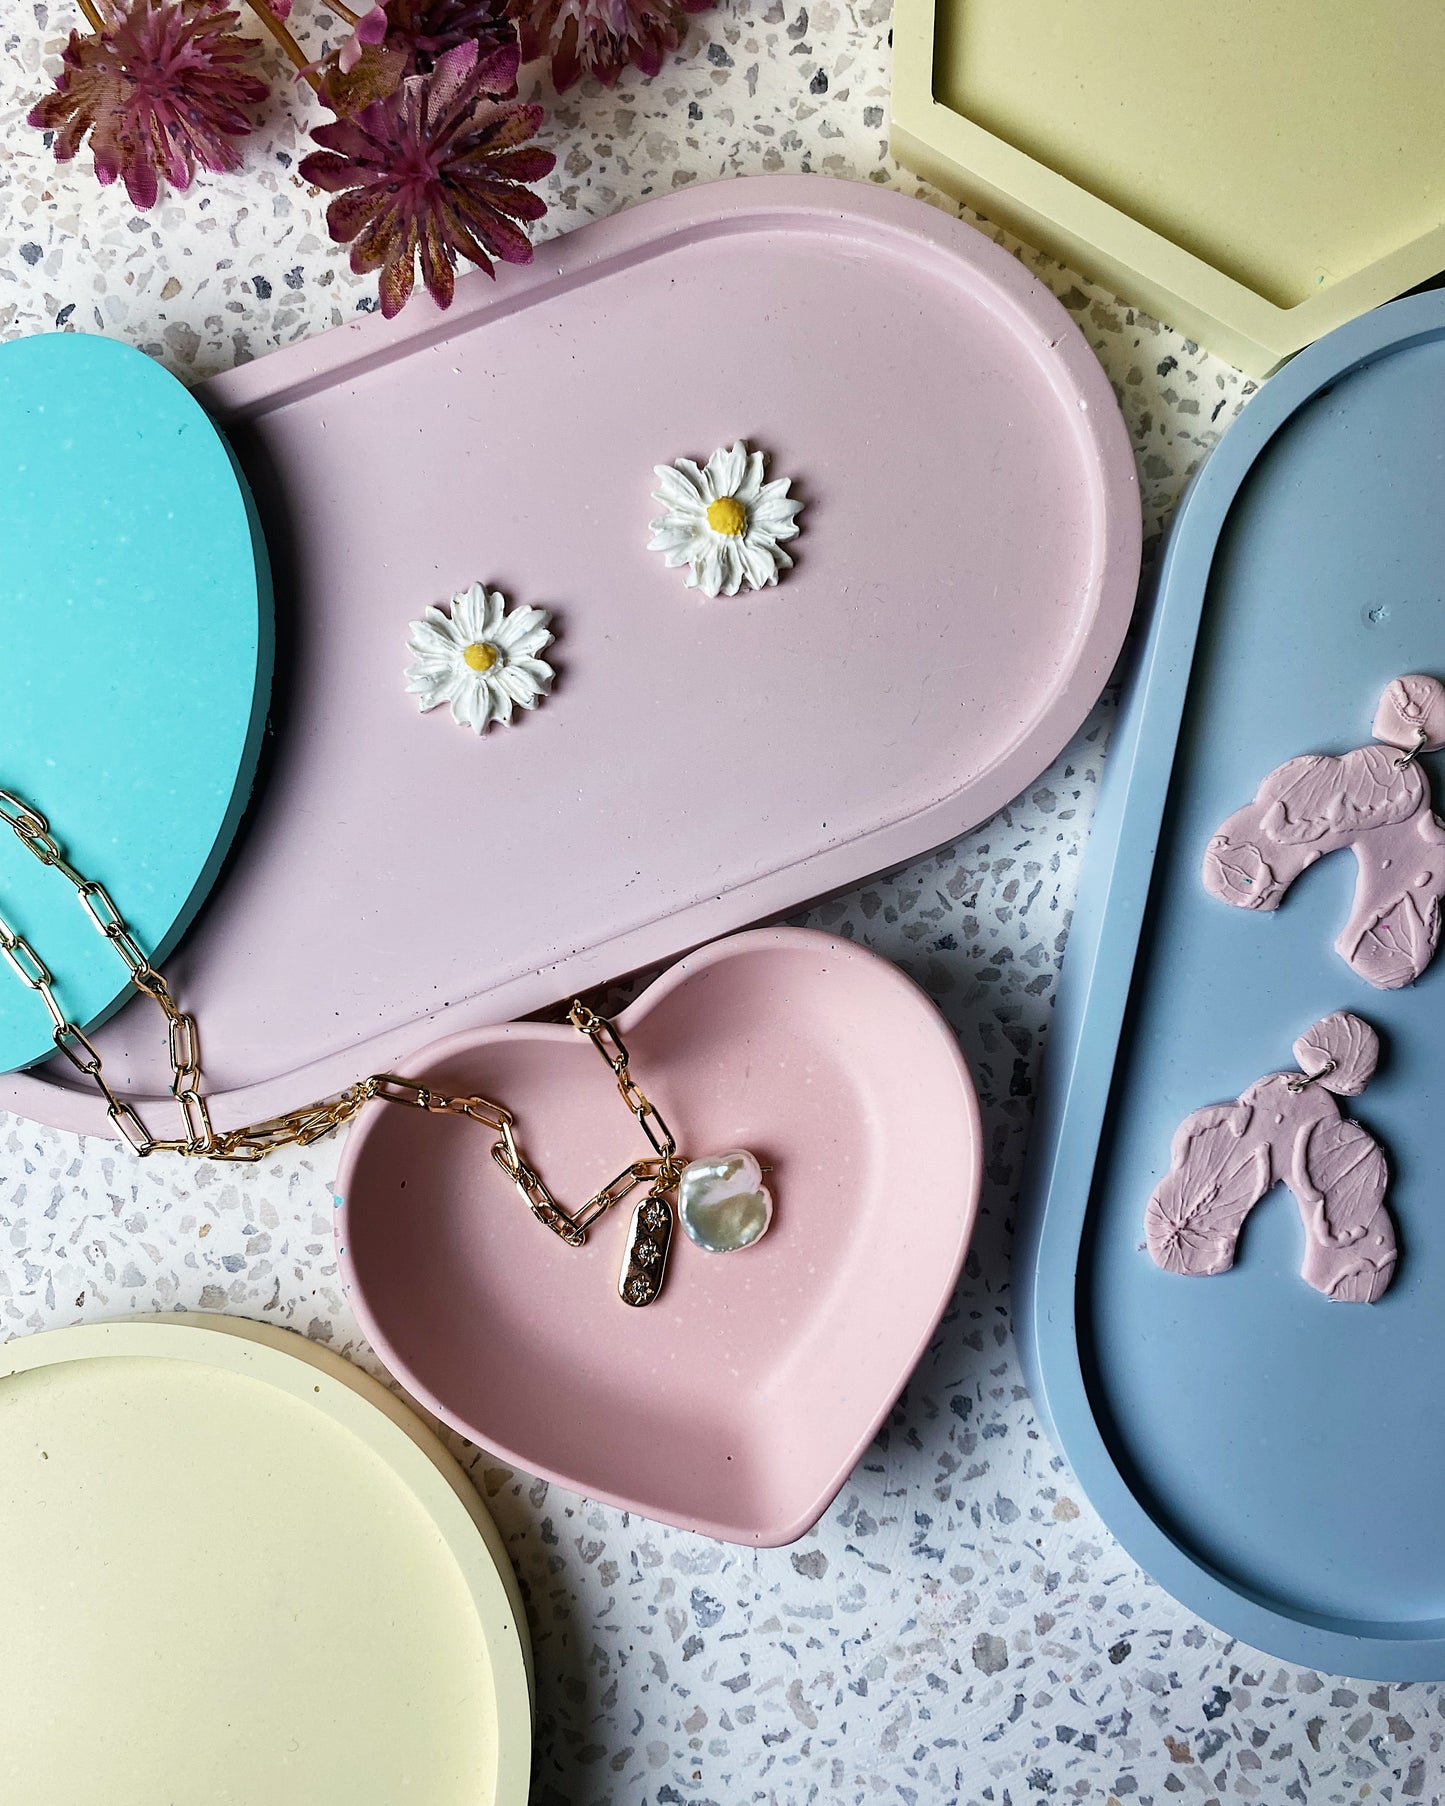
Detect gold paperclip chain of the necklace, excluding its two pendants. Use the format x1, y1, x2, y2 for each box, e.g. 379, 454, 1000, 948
0, 789, 683, 1248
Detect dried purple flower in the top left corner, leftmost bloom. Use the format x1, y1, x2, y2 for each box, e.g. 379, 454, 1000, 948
29, 0, 267, 208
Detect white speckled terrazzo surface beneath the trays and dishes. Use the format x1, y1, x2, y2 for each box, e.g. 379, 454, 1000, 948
0, 0, 1445, 1806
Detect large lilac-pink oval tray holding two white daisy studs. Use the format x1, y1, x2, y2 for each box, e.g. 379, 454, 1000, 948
0, 177, 1140, 1132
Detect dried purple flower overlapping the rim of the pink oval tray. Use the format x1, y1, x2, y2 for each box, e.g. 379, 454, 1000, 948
298, 40, 556, 318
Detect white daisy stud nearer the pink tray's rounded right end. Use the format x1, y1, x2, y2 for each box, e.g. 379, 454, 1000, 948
648, 439, 802, 596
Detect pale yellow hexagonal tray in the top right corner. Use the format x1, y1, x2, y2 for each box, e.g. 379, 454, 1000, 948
892, 0, 1445, 376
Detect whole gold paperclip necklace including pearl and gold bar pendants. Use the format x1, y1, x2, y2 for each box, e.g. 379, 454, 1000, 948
0, 789, 771, 1306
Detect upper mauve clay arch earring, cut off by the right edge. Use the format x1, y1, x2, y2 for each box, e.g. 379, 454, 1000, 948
1203, 677, 1445, 991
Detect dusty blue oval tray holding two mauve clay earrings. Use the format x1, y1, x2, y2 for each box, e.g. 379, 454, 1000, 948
1015, 293, 1445, 1681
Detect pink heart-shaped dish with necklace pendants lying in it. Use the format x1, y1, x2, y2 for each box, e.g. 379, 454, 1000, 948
336, 928, 983, 1546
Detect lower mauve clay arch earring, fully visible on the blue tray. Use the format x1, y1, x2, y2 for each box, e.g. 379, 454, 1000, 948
1143, 1013, 1396, 1304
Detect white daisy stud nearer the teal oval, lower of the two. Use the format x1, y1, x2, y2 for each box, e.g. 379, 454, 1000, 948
406, 583, 556, 733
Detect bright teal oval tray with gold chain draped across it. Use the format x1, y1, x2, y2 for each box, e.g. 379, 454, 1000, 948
0, 332, 273, 1071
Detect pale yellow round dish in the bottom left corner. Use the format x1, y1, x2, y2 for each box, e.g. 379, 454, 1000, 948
0, 1317, 531, 1806
